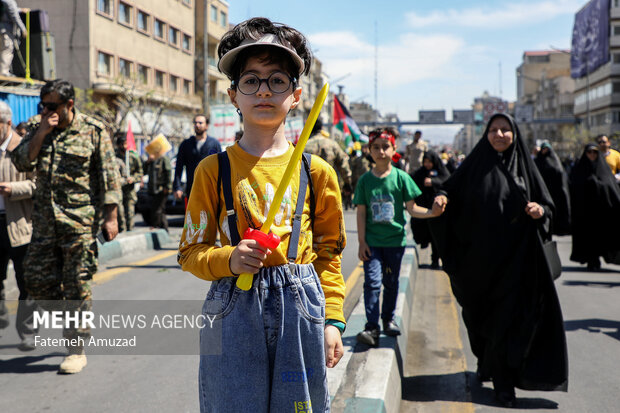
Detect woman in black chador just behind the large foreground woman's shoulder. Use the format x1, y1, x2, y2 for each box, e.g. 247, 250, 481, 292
534, 142, 570, 235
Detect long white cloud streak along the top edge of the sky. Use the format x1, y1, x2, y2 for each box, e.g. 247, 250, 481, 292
406, 0, 585, 30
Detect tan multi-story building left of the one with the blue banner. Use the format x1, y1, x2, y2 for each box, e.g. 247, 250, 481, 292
516, 50, 575, 144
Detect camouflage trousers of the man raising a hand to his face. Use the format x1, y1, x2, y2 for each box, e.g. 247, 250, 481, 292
24, 233, 97, 339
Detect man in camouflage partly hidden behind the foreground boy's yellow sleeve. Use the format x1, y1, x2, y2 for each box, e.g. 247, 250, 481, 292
305, 119, 352, 203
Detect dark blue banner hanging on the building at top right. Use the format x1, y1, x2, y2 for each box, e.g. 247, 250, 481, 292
570, 0, 609, 79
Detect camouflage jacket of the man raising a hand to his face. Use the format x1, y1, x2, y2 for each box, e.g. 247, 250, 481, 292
11, 110, 122, 232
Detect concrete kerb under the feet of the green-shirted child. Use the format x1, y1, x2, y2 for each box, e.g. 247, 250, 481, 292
328, 246, 418, 413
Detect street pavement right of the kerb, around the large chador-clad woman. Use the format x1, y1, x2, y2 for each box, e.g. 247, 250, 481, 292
401, 237, 620, 413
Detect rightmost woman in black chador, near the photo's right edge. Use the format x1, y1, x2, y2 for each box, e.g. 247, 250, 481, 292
570, 144, 620, 271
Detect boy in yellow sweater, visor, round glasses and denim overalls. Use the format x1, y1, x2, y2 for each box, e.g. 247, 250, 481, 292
178, 18, 346, 413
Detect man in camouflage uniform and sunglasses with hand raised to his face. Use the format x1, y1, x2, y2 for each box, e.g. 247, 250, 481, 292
11, 80, 121, 373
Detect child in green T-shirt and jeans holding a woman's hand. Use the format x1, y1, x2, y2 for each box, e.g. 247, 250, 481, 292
353, 128, 442, 347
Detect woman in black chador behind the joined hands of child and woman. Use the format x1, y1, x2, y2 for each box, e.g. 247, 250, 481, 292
411, 151, 450, 269
